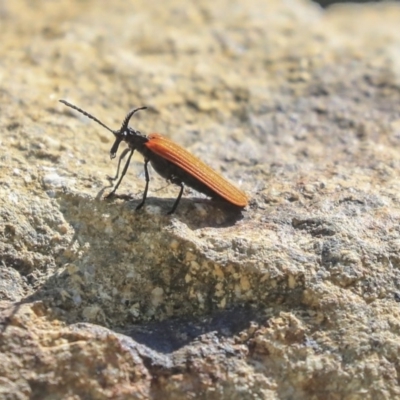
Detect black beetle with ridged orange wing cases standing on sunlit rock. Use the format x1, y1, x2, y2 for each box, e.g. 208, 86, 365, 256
60, 100, 248, 214
